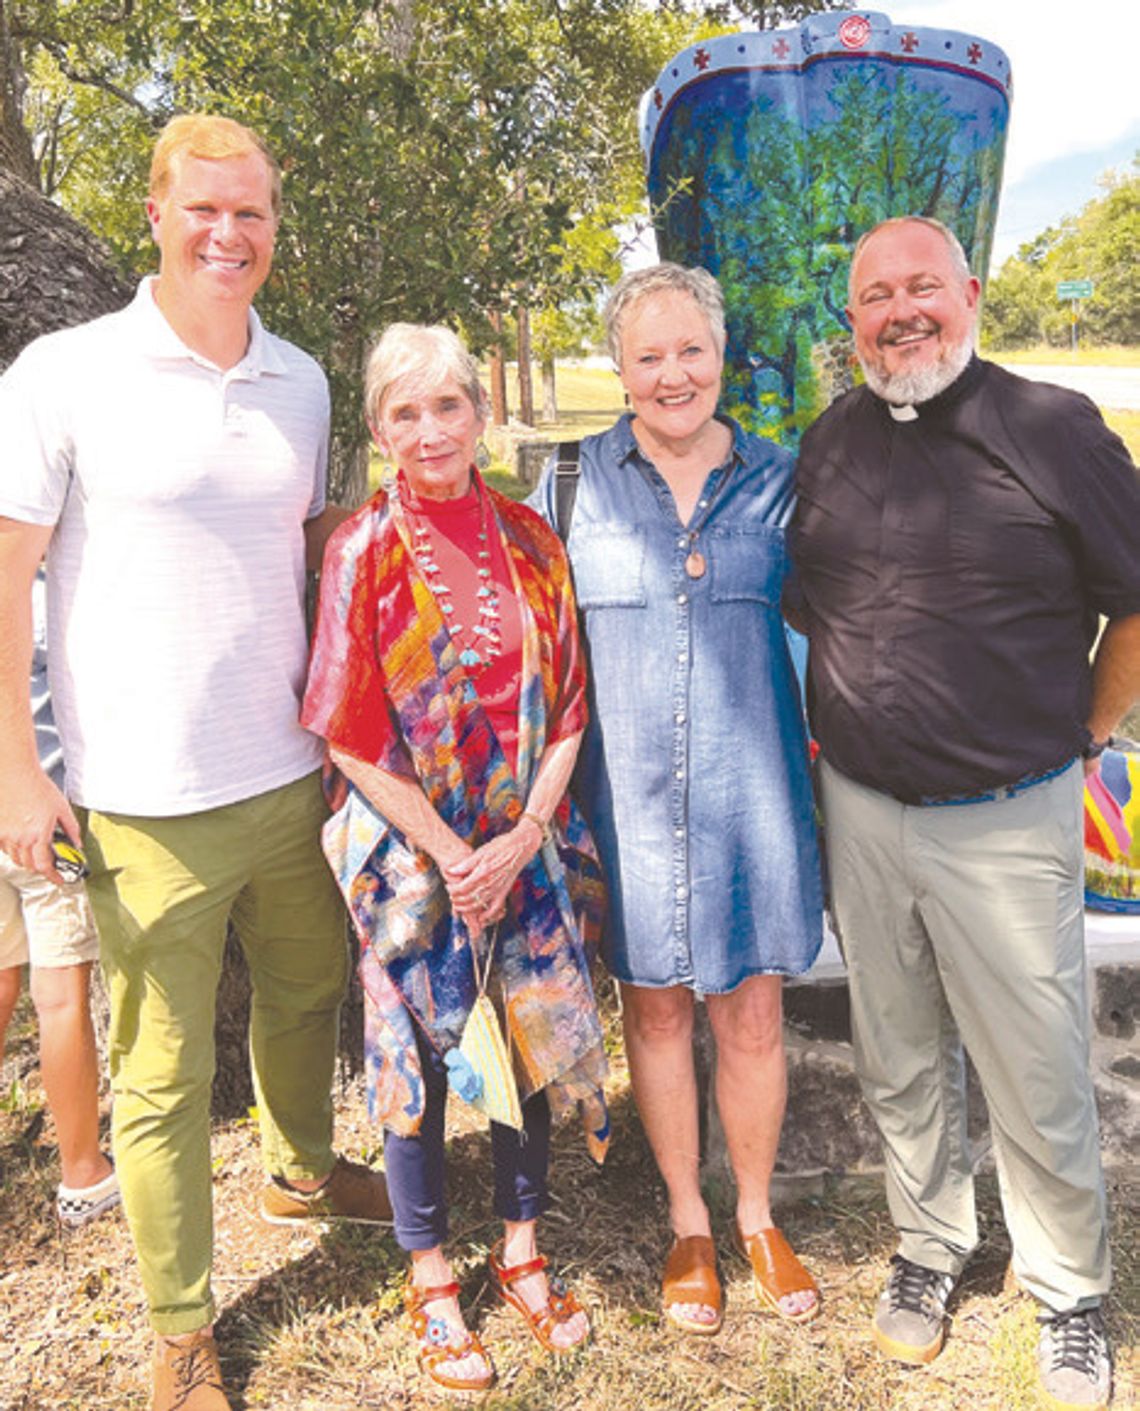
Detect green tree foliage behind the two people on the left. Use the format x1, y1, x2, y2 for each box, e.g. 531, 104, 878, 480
8, 0, 694, 490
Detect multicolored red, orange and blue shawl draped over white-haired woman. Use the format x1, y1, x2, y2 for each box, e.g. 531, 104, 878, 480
302, 481, 608, 1160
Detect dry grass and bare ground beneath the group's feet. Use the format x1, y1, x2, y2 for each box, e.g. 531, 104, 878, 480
0, 982, 1140, 1411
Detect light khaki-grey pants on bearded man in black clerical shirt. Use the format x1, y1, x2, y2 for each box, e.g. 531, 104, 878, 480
823, 765, 1110, 1311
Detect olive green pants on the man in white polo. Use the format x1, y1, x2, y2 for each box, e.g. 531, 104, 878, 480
87, 775, 347, 1333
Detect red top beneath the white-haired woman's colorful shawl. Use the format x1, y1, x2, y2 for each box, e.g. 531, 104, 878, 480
399, 474, 522, 772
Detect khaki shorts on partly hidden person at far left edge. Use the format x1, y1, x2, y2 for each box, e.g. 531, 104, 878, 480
0, 852, 99, 969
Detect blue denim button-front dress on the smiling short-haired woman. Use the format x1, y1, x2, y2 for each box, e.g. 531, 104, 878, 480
532, 416, 823, 993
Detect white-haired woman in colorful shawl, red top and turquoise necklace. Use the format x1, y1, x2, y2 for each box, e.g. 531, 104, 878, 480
302, 325, 608, 1391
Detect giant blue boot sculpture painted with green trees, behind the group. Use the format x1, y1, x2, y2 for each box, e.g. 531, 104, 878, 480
642, 13, 1010, 447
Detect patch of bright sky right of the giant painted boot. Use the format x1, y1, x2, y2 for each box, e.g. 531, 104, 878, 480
876, 0, 1140, 270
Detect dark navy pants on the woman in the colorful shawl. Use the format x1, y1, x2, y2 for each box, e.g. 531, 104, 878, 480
384, 1029, 550, 1250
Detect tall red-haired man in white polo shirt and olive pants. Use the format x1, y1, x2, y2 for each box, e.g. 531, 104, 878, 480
0, 116, 391, 1411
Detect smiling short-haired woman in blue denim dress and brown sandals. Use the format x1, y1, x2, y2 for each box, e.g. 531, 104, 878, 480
532, 264, 823, 1333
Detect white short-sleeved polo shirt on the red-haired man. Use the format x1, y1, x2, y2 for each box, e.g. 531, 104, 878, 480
0, 279, 329, 817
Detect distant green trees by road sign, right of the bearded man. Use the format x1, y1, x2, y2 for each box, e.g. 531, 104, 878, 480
982, 155, 1140, 349
